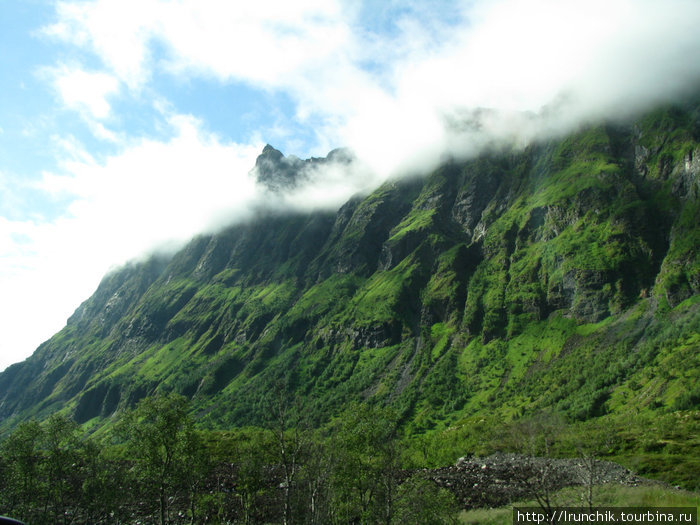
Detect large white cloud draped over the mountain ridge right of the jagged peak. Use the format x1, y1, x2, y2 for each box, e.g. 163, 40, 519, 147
338, 0, 700, 176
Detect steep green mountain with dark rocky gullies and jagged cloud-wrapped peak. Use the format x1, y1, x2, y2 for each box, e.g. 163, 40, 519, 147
0, 100, 700, 431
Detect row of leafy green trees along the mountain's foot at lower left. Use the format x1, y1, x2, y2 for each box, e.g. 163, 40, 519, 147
0, 394, 457, 525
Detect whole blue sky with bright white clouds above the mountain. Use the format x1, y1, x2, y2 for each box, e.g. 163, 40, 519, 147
0, 0, 700, 369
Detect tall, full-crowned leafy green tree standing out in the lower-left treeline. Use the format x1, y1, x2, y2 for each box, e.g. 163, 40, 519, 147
117, 394, 203, 525
